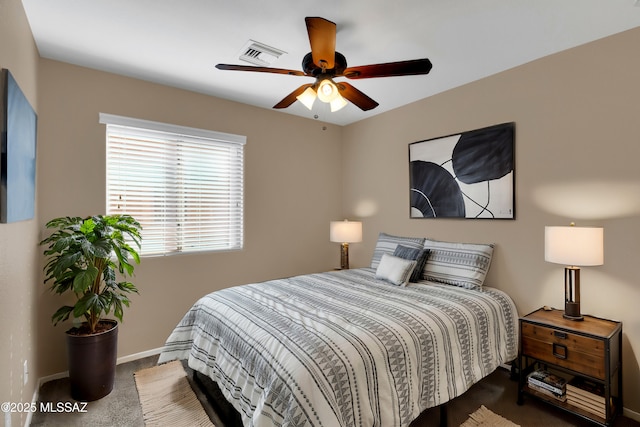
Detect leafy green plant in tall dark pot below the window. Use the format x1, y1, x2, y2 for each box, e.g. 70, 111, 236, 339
40, 215, 142, 401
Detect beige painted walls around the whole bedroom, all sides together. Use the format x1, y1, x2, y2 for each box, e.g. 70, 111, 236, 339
5, 0, 640, 425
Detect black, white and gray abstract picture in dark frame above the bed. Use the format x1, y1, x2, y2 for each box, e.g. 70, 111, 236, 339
409, 122, 515, 219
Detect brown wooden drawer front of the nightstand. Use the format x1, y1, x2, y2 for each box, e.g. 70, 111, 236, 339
521, 323, 607, 379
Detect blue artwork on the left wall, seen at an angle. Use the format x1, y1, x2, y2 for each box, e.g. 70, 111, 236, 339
0, 68, 37, 223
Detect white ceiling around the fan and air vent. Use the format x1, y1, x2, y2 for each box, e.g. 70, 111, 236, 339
22, 0, 640, 125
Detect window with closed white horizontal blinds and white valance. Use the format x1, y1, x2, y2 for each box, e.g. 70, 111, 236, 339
100, 113, 246, 255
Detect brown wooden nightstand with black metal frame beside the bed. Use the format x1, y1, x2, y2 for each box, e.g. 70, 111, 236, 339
518, 308, 622, 426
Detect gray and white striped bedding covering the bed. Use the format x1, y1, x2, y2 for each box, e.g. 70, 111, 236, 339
159, 268, 518, 427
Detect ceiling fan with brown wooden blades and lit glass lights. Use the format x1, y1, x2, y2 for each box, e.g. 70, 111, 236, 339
216, 17, 432, 112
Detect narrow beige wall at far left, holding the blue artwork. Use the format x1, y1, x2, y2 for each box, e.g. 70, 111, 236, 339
0, 0, 40, 425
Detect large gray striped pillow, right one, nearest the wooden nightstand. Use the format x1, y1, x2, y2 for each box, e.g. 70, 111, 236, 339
422, 239, 493, 289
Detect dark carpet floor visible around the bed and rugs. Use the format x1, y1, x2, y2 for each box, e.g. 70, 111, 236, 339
31, 356, 640, 427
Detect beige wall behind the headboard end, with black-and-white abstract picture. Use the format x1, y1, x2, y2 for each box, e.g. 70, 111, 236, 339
342, 29, 640, 413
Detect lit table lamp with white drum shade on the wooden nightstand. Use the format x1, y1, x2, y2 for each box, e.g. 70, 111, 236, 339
544, 223, 604, 320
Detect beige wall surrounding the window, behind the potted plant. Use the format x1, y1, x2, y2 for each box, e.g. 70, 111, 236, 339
37, 59, 342, 375
